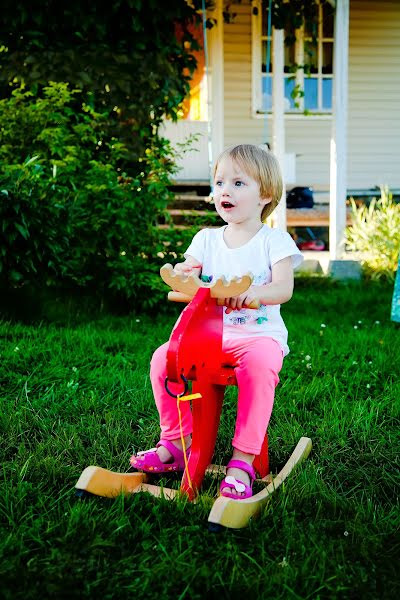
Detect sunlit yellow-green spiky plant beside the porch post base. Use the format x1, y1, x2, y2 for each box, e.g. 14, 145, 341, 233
346, 187, 400, 280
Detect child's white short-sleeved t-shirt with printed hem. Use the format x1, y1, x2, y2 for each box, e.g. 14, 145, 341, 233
184, 225, 304, 355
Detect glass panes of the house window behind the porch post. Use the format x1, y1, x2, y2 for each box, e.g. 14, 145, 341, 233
253, 0, 334, 113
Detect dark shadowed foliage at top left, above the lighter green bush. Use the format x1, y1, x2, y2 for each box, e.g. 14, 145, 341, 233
0, 0, 202, 168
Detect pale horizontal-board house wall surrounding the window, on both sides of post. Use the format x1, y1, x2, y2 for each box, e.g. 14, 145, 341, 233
224, 0, 400, 189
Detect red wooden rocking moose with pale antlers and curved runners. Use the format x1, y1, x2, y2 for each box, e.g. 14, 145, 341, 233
75, 265, 311, 530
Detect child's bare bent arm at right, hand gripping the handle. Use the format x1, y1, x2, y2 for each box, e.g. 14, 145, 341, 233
225, 256, 294, 313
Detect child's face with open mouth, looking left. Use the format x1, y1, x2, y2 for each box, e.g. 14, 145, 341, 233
213, 157, 271, 225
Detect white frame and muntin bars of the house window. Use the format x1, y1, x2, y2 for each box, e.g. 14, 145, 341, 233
251, 0, 335, 119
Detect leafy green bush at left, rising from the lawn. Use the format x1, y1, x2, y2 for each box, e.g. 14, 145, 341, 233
0, 83, 190, 307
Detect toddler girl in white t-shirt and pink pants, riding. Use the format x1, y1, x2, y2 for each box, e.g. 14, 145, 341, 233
131, 144, 303, 499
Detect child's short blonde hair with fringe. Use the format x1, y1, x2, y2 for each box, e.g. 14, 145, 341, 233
214, 144, 283, 221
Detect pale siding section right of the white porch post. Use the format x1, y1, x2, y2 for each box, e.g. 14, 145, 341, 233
348, 0, 400, 188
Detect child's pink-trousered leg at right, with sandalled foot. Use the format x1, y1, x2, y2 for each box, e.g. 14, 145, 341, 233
223, 337, 283, 496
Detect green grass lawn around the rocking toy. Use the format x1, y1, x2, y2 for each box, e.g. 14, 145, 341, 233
0, 279, 400, 600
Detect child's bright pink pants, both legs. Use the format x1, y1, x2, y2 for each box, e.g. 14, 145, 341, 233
150, 337, 283, 455
